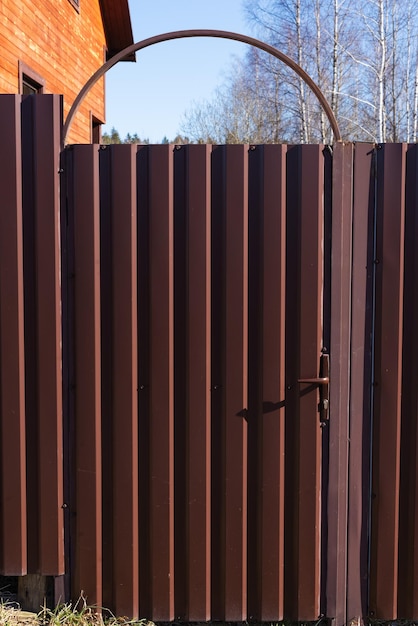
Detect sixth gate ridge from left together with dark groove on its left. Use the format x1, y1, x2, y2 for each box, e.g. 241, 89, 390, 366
248, 146, 286, 621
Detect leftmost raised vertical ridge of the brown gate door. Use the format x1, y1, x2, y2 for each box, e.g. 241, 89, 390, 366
71, 146, 102, 606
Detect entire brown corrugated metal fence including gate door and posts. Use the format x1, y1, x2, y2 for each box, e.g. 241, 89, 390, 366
0, 96, 418, 624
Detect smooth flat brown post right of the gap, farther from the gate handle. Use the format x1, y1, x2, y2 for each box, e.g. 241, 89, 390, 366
347, 144, 376, 620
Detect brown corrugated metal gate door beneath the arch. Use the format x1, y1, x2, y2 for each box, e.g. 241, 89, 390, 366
61, 139, 324, 621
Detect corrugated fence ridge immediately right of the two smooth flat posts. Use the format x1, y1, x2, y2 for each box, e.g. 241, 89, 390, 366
370, 144, 406, 619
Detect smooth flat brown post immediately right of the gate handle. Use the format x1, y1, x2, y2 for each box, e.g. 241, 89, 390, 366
326, 144, 354, 626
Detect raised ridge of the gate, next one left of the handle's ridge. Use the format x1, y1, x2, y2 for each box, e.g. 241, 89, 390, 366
260, 146, 287, 621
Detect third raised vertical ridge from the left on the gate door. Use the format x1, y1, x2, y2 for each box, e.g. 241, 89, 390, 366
148, 145, 174, 621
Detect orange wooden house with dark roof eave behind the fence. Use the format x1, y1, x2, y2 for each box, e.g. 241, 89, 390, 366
0, 0, 135, 143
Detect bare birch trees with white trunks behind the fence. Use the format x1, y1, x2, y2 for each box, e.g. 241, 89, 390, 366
182, 0, 418, 143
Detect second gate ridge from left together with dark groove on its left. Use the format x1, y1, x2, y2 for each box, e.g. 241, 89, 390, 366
100, 146, 139, 616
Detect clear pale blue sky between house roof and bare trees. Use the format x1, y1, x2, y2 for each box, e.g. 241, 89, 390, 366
103, 0, 251, 142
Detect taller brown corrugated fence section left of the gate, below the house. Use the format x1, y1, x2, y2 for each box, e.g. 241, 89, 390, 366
0, 96, 64, 575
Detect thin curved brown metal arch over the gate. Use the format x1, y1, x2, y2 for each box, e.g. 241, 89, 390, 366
63, 29, 341, 145
